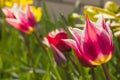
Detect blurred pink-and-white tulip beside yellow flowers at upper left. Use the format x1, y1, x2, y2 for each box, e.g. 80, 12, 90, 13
3, 5, 37, 34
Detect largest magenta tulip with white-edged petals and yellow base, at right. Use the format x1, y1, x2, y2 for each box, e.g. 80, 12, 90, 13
63, 16, 114, 67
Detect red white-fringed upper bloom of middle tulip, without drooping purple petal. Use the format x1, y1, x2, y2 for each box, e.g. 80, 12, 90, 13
44, 30, 70, 52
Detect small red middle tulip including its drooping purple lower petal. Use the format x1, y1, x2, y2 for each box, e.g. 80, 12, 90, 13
43, 29, 70, 66
